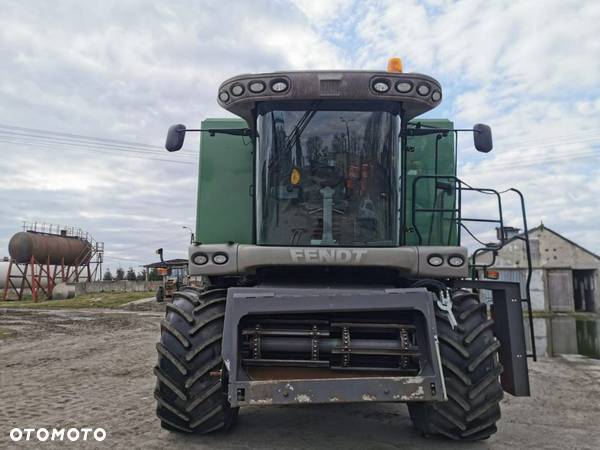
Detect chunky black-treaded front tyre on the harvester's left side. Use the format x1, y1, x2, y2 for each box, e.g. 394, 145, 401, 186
154, 287, 238, 434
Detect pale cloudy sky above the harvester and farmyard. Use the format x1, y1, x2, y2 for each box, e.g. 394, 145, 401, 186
0, 0, 600, 268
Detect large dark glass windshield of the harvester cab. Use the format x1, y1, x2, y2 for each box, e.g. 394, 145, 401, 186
256, 104, 400, 247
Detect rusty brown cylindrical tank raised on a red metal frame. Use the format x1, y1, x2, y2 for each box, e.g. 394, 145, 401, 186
8, 231, 92, 266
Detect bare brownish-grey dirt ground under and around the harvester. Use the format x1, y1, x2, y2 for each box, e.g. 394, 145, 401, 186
0, 309, 600, 449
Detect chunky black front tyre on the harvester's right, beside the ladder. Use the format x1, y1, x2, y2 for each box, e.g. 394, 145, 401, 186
408, 291, 503, 441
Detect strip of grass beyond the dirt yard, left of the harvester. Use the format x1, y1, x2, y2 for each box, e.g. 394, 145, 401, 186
0, 292, 154, 309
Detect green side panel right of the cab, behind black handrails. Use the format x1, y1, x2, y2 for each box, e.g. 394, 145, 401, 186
405, 119, 458, 245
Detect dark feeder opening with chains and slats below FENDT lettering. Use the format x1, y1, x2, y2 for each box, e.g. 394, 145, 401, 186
240, 311, 421, 375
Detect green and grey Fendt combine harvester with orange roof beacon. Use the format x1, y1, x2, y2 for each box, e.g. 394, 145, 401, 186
155, 59, 535, 441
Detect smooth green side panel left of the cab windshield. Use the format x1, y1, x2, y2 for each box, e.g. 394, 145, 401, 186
196, 119, 253, 244
